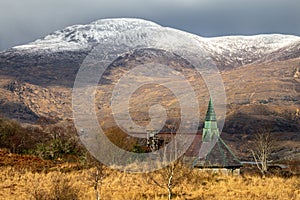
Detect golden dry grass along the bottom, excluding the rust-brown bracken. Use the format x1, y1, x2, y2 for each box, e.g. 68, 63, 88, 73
0, 164, 300, 200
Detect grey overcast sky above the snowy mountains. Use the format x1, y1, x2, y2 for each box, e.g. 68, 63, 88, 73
0, 0, 300, 50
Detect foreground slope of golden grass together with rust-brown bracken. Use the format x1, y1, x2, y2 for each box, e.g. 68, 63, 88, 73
0, 150, 300, 200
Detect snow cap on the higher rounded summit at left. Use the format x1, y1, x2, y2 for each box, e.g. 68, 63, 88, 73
14, 18, 162, 51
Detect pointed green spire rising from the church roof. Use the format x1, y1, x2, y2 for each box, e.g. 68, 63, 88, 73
202, 98, 220, 142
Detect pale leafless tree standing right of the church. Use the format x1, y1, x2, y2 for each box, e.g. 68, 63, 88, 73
251, 128, 276, 177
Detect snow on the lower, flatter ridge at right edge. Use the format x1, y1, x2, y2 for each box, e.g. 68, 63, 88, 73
200, 34, 300, 67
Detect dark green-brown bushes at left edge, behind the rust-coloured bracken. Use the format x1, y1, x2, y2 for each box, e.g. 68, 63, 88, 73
0, 118, 84, 160
